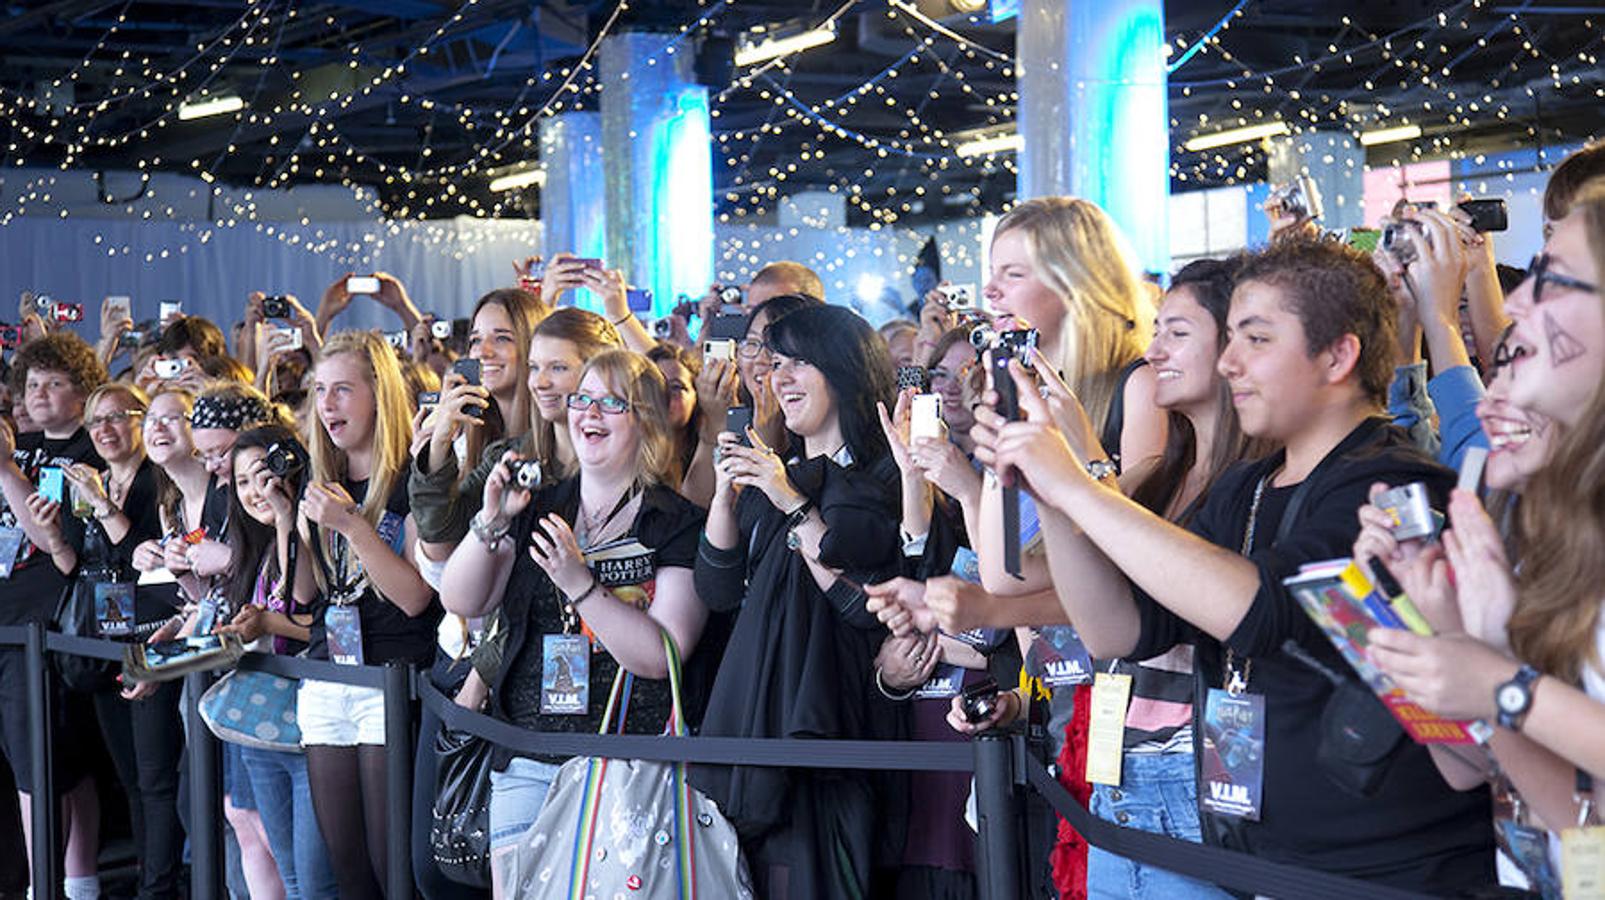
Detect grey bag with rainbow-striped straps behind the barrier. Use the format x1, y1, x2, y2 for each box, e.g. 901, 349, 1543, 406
491, 632, 753, 900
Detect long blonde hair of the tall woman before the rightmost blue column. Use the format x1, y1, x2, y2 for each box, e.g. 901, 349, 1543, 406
992, 197, 1154, 428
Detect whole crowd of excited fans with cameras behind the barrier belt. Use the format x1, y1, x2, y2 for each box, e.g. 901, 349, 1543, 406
0, 140, 1605, 900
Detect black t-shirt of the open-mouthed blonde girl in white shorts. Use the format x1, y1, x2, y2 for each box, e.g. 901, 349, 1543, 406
307, 478, 441, 666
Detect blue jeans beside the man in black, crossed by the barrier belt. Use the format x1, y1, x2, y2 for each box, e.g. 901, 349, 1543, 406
1087, 752, 1231, 900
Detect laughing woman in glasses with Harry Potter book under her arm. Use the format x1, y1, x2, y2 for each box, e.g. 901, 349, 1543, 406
441, 350, 708, 897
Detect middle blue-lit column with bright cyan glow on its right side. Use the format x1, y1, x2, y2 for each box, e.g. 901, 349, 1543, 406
600, 32, 713, 316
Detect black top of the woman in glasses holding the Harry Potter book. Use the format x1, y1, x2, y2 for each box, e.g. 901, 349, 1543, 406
493, 476, 706, 760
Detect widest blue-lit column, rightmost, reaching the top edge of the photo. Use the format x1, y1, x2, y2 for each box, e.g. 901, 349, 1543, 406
1014, 0, 1170, 271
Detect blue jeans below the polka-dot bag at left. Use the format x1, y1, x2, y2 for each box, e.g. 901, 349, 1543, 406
241, 748, 340, 900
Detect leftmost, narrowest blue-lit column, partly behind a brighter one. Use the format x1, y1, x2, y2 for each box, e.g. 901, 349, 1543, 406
541, 112, 607, 260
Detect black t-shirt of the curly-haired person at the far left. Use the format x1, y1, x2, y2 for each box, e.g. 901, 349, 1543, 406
0, 428, 106, 626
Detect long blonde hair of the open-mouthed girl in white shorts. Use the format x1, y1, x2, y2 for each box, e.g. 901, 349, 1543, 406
310, 330, 412, 528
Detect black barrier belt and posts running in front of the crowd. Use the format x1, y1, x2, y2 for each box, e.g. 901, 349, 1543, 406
0, 626, 1450, 900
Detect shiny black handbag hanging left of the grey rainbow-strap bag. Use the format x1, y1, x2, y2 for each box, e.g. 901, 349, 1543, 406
429, 727, 494, 887
